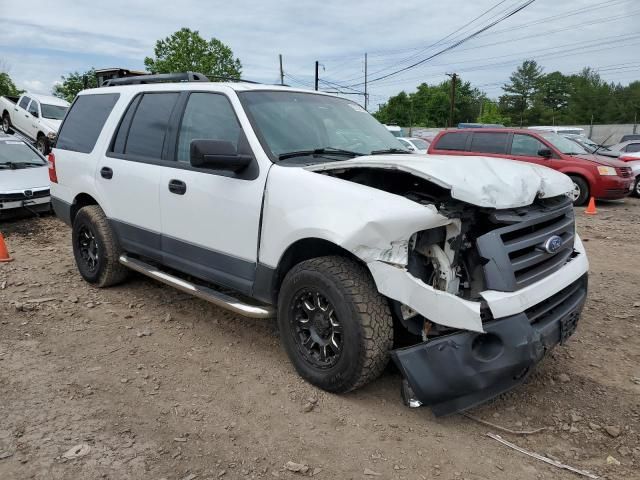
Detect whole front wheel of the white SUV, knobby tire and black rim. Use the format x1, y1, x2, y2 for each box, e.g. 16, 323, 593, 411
278, 256, 393, 393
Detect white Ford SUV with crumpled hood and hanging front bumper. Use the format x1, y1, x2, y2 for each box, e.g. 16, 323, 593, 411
49, 74, 588, 415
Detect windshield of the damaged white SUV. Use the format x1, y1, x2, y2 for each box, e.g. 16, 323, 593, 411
238, 91, 406, 162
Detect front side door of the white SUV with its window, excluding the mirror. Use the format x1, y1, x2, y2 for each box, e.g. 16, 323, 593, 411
160, 92, 266, 293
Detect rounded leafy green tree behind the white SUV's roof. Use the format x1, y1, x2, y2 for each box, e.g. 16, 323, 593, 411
144, 28, 242, 79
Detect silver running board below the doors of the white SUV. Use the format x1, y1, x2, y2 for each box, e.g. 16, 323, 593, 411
119, 255, 276, 318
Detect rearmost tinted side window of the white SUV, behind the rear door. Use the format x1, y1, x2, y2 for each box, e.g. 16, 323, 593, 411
56, 93, 120, 153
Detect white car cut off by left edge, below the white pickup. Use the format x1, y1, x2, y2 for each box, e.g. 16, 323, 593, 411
0, 134, 51, 218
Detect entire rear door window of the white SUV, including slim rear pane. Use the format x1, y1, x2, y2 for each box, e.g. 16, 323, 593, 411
113, 93, 179, 159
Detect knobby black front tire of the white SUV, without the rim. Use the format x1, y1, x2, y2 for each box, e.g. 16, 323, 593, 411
278, 256, 393, 393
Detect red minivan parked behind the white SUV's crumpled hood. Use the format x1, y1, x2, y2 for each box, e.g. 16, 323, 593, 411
427, 128, 634, 205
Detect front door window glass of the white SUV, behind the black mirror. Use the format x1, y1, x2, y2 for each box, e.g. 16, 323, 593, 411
178, 93, 240, 163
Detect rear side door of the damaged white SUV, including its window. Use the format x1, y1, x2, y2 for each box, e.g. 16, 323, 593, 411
100, 92, 180, 261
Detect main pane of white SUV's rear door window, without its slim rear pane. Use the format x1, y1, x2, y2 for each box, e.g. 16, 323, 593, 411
124, 93, 178, 159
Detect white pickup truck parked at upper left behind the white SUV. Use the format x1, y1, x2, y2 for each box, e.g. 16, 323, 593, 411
0, 93, 69, 155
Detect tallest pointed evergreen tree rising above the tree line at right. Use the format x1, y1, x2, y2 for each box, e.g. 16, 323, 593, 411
500, 60, 542, 126
